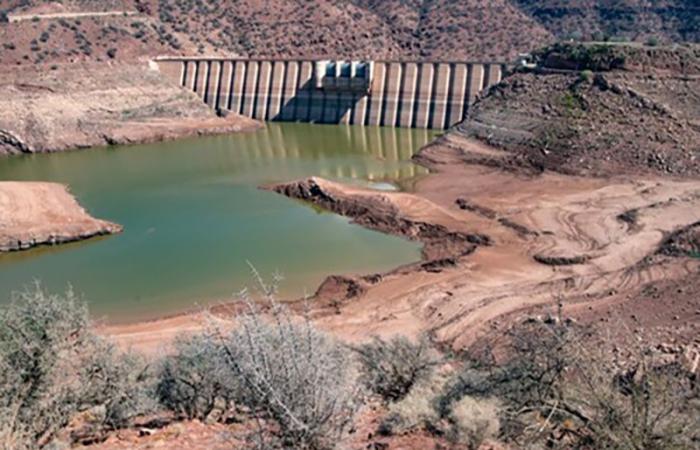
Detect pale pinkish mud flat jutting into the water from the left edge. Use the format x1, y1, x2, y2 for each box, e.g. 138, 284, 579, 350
0, 182, 122, 252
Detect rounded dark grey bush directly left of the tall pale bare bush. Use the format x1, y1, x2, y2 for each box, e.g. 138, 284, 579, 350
157, 334, 241, 420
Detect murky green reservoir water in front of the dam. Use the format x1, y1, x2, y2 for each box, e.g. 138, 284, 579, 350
0, 124, 433, 320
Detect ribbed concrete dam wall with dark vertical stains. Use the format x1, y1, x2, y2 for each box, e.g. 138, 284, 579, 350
155, 57, 508, 129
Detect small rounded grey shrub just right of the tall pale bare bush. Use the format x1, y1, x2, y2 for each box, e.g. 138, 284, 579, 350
355, 336, 438, 401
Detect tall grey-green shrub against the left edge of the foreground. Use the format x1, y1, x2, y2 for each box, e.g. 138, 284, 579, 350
0, 286, 89, 448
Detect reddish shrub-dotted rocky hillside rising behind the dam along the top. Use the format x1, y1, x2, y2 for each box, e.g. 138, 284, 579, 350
0, 0, 700, 65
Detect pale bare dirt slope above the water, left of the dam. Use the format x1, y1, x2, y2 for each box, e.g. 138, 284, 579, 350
0, 64, 260, 155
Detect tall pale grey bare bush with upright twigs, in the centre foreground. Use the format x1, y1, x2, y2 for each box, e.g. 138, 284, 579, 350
211, 272, 357, 449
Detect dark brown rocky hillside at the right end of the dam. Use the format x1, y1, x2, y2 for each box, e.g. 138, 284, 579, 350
455, 45, 700, 176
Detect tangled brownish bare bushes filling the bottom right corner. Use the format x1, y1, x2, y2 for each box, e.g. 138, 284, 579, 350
437, 321, 700, 450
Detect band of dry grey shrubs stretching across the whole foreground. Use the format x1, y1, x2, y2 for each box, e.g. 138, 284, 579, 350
0, 283, 700, 450
